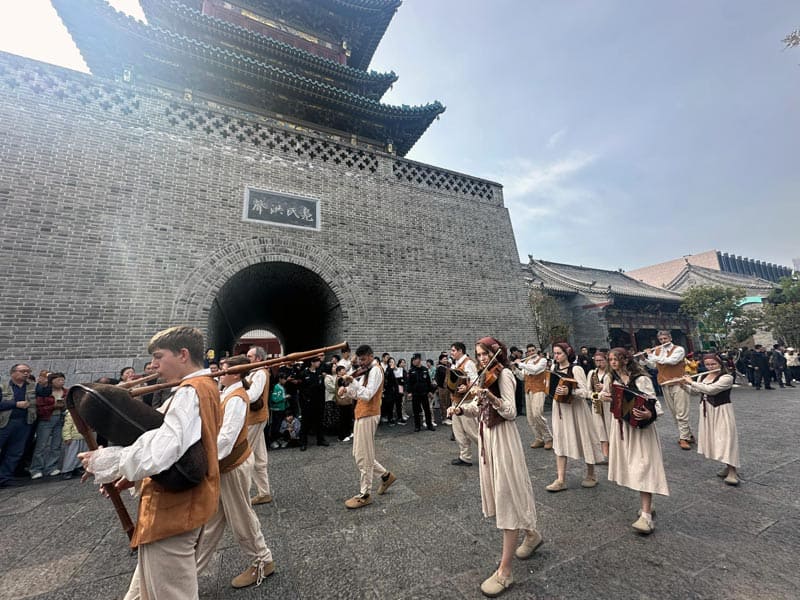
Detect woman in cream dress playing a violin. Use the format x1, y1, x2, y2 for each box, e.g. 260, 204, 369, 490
448, 337, 542, 598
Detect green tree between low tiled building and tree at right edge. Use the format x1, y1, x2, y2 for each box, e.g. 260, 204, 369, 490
680, 285, 747, 342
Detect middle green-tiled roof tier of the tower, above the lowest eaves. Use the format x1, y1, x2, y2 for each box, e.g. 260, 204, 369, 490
140, 0, 397, 100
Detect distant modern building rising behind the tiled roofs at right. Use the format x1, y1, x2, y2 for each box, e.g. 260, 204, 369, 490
627, 250, 796, 287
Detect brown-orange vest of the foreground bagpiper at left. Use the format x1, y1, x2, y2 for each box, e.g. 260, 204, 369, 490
131, 376, 222, 548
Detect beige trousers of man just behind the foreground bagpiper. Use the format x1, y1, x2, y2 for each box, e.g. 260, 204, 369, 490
197, 454, 272, 573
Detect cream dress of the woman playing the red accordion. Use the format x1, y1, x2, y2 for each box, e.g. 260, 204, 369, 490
608, 375, 669, 496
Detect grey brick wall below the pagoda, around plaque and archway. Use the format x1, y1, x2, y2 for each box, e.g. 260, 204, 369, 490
0, 53, 532, 376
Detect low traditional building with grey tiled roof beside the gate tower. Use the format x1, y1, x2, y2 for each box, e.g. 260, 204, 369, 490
524, 257, 695, 350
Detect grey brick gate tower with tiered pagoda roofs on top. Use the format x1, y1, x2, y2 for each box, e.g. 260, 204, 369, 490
0, 0, 531, 380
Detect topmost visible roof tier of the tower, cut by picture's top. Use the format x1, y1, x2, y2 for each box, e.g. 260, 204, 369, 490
177, 0, 402, 70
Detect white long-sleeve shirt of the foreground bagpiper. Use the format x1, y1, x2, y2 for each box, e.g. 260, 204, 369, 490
90, 369, 211, 483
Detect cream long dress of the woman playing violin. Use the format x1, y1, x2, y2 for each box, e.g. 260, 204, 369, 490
456, 369, 536, 530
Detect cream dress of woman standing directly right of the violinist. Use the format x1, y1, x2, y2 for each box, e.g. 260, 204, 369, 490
552, 366, 603, 465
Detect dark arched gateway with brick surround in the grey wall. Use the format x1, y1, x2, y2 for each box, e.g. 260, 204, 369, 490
171, 238, 364, 355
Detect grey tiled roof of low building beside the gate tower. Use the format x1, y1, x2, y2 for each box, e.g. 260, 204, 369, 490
525, 256, 681, 303
